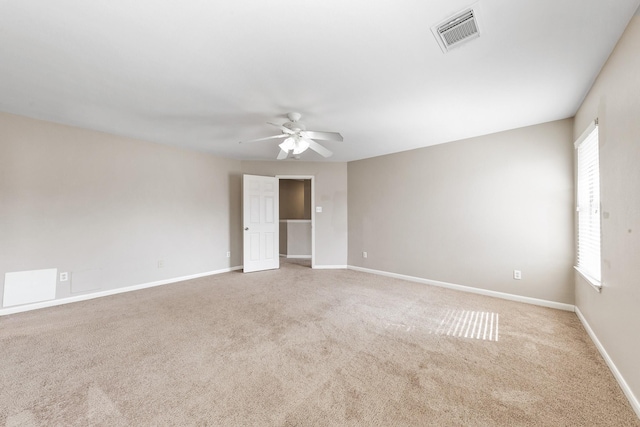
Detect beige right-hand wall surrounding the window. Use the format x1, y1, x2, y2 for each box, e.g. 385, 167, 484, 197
573, 14, 640, 410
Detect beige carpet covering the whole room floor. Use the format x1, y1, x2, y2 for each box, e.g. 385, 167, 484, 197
0, 263, 640, 426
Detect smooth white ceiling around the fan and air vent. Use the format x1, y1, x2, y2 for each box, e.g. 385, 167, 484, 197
0, 0, 640, 162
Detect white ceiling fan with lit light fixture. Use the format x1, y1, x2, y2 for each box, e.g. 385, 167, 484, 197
240, 113, 343, 160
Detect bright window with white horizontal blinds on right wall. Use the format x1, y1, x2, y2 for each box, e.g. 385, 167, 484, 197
575, 120, 601, 289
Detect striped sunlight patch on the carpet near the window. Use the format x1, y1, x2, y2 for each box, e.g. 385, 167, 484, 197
429, 310, 500, 341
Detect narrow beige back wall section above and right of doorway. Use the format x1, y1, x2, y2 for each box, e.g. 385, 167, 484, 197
242, 161, 347, 267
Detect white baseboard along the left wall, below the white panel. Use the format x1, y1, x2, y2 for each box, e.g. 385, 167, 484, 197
0, 266, 242, 316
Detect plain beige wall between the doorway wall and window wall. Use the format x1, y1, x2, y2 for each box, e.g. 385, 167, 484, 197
348, 119, 574, 304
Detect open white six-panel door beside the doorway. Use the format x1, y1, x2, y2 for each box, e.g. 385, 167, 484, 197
242, 175, 280, 273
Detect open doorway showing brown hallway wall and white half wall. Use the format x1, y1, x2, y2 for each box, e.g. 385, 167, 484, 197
277, 176, 315, 268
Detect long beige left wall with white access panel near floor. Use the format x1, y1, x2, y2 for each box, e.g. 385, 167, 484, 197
0, 113, 242, 310
